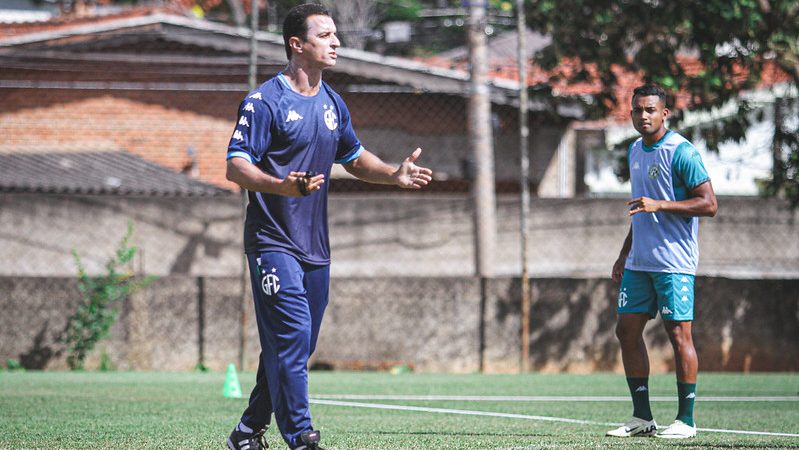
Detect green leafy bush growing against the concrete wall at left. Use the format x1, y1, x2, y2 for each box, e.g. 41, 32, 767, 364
64, 223, 153, 370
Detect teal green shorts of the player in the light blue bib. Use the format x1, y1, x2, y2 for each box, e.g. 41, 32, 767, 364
616, 269, 694, 321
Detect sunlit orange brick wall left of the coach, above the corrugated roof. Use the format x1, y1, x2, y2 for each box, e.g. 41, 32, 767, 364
0, 89, 242, 189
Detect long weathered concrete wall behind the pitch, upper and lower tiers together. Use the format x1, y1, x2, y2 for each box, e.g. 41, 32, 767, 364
0, 194, 799, 371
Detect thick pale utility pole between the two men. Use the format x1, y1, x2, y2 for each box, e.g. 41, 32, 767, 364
468, 1, 496, 371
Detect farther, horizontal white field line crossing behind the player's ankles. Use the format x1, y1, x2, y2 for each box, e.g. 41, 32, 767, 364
312, 394, 799, 402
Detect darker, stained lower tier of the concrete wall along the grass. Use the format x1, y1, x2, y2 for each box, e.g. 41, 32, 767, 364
0, 276, 799, 373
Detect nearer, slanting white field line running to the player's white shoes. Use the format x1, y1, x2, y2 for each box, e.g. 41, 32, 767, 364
311, 396, 799, 438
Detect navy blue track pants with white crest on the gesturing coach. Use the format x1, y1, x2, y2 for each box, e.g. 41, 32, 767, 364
241, 252, 330, 448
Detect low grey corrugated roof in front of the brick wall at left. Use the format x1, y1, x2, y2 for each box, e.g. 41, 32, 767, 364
0, 151, 231, 197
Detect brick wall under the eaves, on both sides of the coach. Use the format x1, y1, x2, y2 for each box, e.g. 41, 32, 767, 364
0, 83, 562, 190
